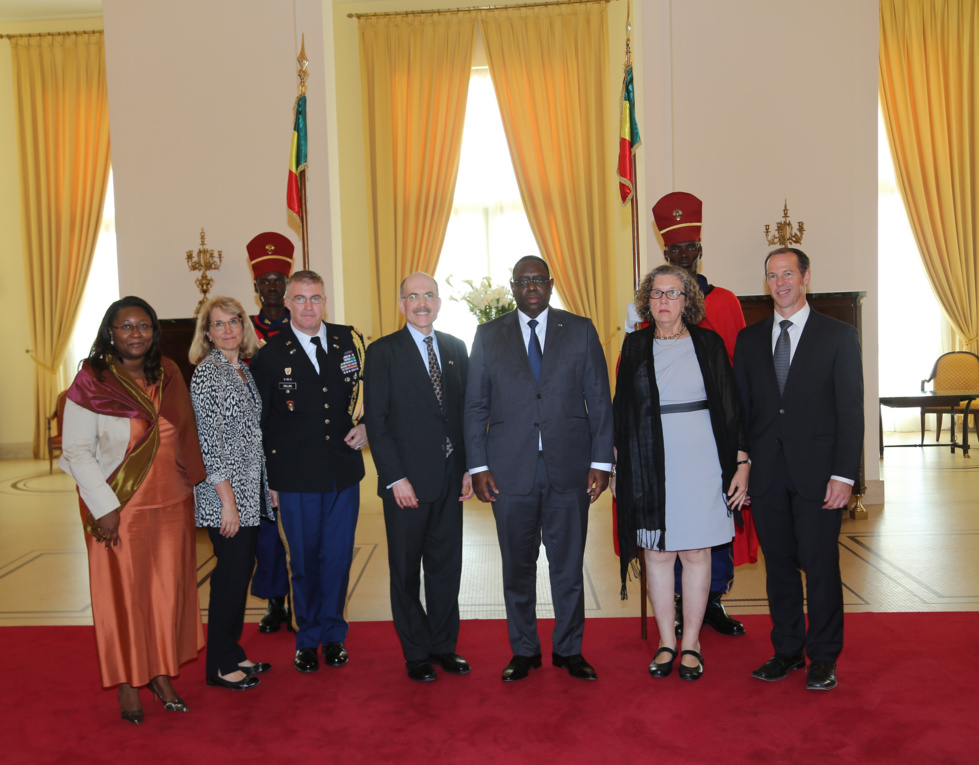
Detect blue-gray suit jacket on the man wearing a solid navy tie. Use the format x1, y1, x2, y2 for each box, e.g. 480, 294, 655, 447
465, 308, 613, 495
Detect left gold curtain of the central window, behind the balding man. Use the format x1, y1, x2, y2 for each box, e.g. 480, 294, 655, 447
359, 13, 476, 336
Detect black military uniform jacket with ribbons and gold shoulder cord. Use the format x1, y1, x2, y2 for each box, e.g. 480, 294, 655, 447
250, 322, 364, 492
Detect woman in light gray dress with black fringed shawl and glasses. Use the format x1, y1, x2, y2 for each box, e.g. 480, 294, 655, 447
612, 265, 749, 680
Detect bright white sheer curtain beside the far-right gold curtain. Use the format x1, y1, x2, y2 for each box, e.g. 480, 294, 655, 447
877, 108, 949, 433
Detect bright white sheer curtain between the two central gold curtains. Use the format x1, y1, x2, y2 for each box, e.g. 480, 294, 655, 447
435, 67, 560, 347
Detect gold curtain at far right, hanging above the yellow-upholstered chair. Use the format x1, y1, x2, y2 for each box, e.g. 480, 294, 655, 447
878, 0, 979, 352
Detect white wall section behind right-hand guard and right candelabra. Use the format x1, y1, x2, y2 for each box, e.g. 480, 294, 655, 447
636, 0, 880, 489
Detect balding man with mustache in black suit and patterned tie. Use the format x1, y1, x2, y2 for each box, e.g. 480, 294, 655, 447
364, 273, 472, 682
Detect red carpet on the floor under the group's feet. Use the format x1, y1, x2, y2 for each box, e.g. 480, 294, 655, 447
0, 613, 979, 765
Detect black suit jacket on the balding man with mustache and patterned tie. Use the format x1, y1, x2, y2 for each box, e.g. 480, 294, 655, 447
364, 327, 469, 502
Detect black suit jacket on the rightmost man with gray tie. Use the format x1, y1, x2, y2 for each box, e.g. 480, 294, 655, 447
734, 311, 863, 500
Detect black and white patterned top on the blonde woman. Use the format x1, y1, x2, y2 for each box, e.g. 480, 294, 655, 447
190, 348, 274, 527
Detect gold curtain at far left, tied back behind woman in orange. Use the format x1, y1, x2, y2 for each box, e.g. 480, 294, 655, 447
10, 32, 109, 459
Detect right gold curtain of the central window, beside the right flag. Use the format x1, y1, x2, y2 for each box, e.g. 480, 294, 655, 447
480, 1, 618, 368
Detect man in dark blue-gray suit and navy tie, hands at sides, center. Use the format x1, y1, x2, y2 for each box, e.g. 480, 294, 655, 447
465, 255, 612, 682
